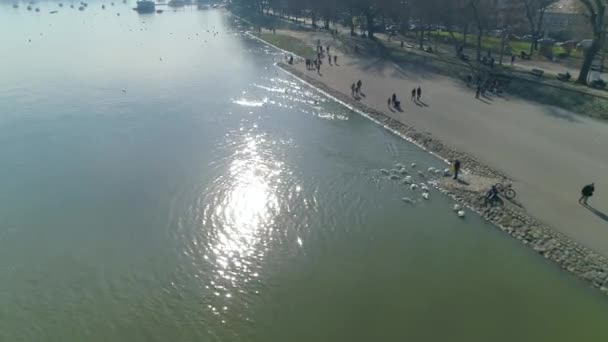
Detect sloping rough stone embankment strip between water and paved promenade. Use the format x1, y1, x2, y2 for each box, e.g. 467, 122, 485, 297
278, 63, 608, 295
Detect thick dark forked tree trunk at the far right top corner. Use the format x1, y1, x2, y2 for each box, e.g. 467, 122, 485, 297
576, 0, 606, 84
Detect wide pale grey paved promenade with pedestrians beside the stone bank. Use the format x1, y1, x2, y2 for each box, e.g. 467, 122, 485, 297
288, 32, 608, 256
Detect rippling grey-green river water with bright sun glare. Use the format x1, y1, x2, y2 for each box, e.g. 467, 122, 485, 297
0, 2, 608, 342
